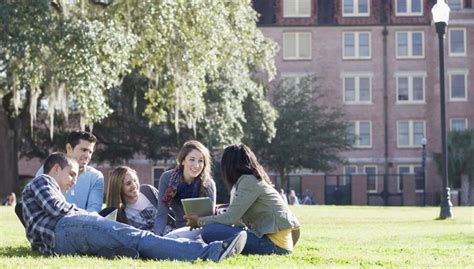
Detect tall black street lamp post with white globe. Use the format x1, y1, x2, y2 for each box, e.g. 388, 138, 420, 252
431, 0, 453, 219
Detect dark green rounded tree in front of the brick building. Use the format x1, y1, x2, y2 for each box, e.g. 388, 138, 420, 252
250, 76, 349, 187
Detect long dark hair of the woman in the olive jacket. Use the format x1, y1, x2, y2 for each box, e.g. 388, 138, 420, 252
221, 144, 271, 188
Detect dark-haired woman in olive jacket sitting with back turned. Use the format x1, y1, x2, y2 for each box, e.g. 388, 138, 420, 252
186, 144, 300, 255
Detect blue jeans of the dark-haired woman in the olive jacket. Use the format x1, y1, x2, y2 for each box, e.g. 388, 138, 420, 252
201, 223, 291, 255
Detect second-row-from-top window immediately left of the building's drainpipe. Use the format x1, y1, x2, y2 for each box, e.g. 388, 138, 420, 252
342, 32, 370, 59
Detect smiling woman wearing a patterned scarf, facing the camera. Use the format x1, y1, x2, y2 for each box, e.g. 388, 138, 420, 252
155, 140, 216, 238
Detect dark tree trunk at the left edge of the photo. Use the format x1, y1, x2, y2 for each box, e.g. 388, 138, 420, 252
0, 104, 20, 197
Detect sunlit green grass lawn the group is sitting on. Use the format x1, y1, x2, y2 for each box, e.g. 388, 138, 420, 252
0, 206, 474, 268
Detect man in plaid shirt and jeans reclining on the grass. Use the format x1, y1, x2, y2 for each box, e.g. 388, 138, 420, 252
22, 153, 247, 262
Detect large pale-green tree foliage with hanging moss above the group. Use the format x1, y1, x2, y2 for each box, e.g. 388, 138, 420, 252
0, 0, 276, 196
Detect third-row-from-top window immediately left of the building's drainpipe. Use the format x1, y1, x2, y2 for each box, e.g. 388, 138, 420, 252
342, 74, 372, 104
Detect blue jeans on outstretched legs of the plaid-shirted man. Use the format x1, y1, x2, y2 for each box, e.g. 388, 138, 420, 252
54, 215, 222, 261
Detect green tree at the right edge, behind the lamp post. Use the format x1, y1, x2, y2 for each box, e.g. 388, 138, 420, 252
433, 129, 474, 205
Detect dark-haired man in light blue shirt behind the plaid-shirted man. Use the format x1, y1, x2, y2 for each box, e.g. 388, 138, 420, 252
36, 131, 104, 212
